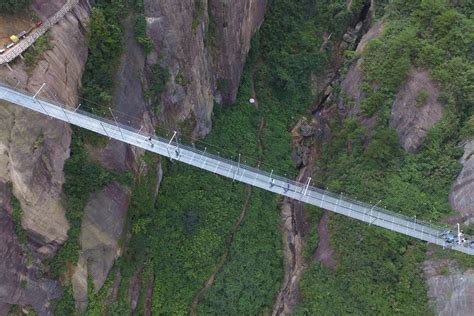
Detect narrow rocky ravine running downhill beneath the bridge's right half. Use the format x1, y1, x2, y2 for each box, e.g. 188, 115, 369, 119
272, 3, 372, 316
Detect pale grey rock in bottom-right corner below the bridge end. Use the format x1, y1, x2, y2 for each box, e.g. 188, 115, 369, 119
423, 259, 474, 316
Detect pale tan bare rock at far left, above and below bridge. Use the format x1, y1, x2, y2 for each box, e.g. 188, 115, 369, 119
0, 1, 89, 250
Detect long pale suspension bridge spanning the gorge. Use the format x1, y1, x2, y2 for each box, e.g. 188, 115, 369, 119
0, 85, 474, 255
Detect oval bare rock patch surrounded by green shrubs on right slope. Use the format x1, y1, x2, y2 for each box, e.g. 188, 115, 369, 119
390, 69, 443, 152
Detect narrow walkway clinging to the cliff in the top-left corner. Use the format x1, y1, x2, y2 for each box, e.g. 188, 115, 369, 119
0, 0, 79, 65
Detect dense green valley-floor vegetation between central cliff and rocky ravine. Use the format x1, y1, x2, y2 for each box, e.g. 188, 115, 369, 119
137, 1, 370, 315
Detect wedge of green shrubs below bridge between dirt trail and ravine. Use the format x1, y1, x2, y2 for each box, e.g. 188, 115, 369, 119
198, 190, 282, 315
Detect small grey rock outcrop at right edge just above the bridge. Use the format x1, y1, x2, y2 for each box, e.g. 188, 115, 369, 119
449, 140, 474, 224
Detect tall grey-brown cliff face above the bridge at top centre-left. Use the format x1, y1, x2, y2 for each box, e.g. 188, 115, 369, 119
145, 0, 266, 137
